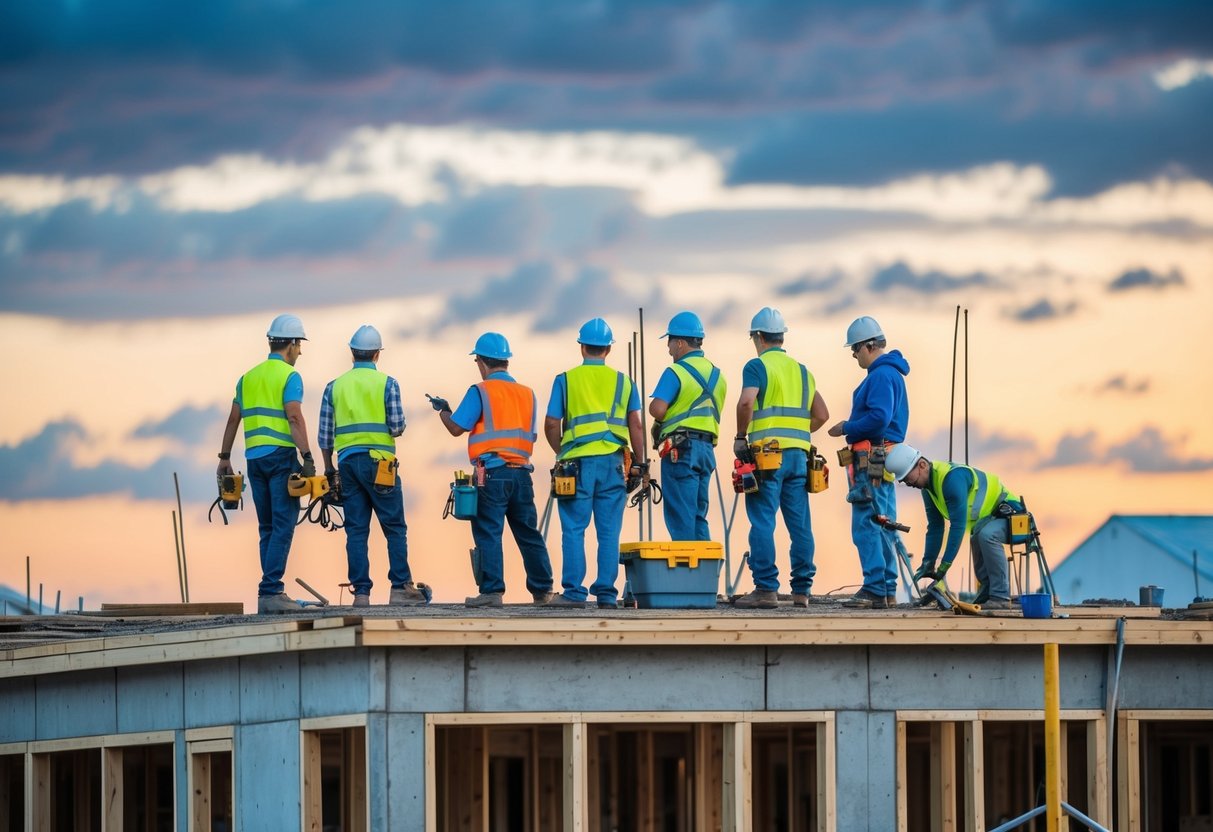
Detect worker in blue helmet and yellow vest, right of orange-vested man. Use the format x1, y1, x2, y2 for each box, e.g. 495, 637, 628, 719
543, 318, 649, 609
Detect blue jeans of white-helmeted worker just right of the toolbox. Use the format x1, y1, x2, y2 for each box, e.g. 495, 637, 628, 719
746, 448, 818, 595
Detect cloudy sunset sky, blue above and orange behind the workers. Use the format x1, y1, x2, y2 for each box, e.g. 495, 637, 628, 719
0, 0, 1213, 609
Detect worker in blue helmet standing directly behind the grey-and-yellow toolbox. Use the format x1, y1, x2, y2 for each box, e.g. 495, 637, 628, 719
649, 312, 727, 540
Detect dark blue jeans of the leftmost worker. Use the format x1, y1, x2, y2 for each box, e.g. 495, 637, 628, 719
249, 448, 300, 595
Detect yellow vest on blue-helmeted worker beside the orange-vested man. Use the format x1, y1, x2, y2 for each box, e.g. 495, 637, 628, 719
559, 364, 632, 460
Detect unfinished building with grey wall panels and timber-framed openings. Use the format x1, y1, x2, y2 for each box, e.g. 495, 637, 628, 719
0, 604, 1213, 832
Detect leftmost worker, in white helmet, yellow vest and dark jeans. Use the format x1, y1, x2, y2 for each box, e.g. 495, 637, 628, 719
217, 314, 315, 614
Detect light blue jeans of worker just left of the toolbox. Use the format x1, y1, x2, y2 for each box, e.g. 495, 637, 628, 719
556, 451, 627, 604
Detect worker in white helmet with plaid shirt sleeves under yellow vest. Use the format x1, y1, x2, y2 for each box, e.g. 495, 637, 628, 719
320, 325, 428, 606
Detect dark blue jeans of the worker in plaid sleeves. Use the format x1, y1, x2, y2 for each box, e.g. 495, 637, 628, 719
338, 451, 412, 595
